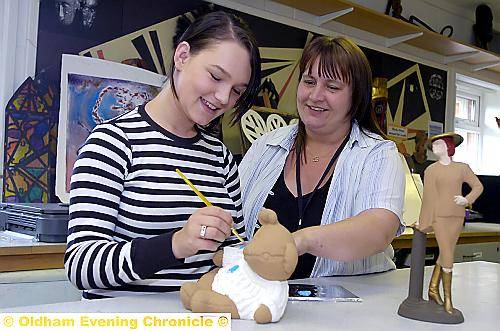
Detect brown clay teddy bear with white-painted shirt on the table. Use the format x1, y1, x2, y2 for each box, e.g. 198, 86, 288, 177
181, 209, 298, 323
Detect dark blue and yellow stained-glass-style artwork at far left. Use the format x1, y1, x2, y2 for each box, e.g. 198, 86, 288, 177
3, 77, 57, 203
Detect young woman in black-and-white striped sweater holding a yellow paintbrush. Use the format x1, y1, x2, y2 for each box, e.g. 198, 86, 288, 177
65, 12, 260, 298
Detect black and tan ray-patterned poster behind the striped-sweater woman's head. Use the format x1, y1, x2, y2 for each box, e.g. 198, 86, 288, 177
79, 4, 306, 120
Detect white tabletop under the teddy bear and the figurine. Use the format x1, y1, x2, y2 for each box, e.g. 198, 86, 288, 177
0, 262, 500, 331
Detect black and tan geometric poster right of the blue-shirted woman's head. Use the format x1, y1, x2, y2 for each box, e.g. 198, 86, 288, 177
362, 48, 447, 161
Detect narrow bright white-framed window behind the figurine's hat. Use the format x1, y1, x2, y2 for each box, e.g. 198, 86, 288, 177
453, 85, 481, 172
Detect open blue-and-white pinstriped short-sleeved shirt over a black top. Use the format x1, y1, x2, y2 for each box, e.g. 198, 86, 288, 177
239, 122, 405, 277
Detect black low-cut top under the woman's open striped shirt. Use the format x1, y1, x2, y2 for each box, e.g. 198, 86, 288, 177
262, 171, 332, 279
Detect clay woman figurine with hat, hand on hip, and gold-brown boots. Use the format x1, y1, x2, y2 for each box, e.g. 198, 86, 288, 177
417, 132, 483, 314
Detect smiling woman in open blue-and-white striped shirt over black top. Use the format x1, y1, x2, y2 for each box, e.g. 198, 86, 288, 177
239, 37, 404, 278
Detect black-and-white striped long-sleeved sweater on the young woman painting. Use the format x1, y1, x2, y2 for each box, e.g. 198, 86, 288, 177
64, 106, 245, 298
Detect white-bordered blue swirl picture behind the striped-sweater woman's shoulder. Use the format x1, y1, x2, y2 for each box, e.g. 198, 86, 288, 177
56, 54, 165, 203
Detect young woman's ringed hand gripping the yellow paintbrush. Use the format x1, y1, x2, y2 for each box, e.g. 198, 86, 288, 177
172, 206, 233, 259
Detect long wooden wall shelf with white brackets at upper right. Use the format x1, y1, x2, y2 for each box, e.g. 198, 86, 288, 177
275, 0, 500, 73
